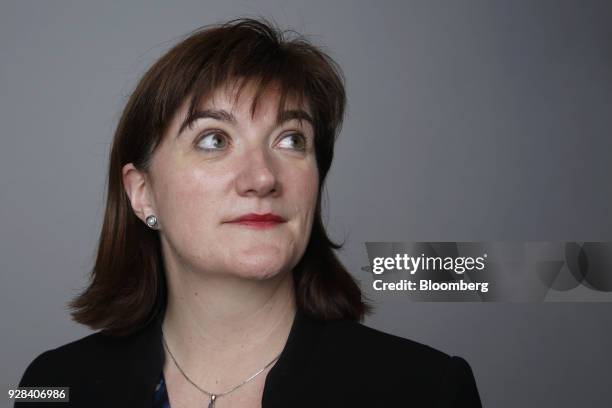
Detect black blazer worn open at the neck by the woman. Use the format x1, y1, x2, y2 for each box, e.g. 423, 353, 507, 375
15, 311, 481, 408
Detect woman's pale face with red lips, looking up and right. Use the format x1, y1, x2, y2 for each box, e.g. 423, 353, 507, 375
132, 83, 318, 279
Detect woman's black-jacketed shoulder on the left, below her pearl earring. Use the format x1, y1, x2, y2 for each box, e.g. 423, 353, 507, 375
15, 324, 163, 407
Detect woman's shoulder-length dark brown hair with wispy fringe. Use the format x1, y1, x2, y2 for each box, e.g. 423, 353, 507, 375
69, 18, 371, 335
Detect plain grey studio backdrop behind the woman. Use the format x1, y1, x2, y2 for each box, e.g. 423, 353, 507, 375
0, 0, 612, 407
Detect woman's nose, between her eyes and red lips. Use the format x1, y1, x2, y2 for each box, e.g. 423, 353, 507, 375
236, 147, 279, 196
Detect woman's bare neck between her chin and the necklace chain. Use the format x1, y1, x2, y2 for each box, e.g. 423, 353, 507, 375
162, 260, 296, 390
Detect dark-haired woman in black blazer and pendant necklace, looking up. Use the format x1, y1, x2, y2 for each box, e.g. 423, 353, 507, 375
16, 19, 480, 408
